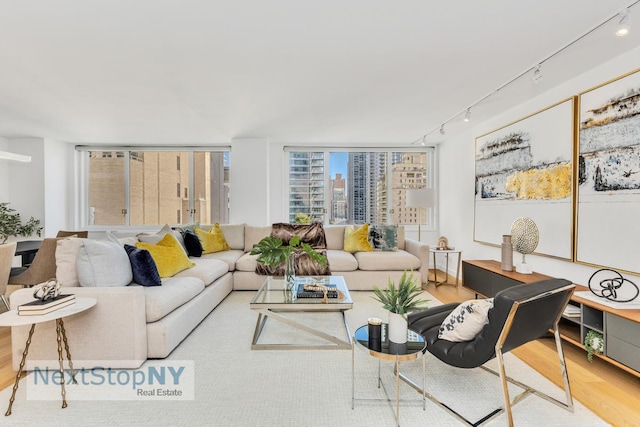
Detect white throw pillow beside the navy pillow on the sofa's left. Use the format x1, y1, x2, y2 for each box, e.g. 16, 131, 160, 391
77, 240, 133, 287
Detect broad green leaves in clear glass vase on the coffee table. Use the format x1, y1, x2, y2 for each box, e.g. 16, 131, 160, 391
251, 236, 327, 288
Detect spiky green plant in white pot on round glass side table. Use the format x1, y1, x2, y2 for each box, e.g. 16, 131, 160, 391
373, 270, 429, 344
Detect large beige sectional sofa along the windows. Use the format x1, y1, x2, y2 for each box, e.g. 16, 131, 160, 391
10, 224, 429, 370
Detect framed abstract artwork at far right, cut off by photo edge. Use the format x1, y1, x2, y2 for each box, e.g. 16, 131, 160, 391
575, 69, 640, 274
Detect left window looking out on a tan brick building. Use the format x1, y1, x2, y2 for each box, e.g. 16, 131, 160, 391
84, 147, 229, 226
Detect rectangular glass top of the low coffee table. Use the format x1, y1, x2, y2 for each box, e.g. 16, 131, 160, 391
250, 276, 353, 305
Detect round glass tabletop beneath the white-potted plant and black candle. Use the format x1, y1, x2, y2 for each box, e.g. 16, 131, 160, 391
353, 323, 427, 360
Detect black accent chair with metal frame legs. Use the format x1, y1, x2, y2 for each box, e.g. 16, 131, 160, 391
403, 279, 575, 426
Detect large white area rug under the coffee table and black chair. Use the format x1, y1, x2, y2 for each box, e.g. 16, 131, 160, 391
0, 291, 608, 427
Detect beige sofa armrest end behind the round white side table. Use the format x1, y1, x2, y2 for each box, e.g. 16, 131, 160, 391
10, 286, 147, 370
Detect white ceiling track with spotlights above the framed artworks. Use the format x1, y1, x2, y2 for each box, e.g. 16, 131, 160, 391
411, 0, 640, 145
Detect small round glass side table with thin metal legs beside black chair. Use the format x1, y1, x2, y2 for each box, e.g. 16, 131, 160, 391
351, 323, 427, 426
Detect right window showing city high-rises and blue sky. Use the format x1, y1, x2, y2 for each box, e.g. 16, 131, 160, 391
288, 148, 435, 228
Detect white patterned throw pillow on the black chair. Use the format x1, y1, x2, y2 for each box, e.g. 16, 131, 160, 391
438, 298, 493, 342
